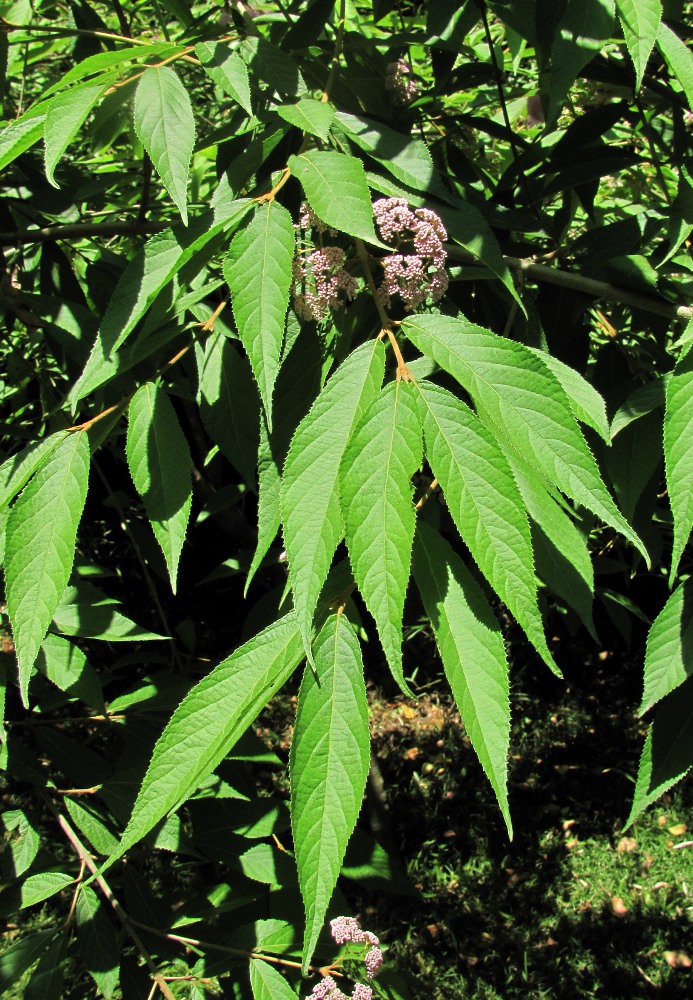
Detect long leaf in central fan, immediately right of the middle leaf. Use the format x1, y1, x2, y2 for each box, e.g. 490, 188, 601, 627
419, 382, 557, 672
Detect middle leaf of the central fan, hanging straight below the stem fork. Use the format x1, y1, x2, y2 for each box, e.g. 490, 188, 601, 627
339, 380, 423, 694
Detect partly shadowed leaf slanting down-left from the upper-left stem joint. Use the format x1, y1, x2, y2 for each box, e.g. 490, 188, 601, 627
70, 200, 253, 405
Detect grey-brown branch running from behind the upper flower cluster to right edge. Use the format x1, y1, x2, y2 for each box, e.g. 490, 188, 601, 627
445, 244, 693, 322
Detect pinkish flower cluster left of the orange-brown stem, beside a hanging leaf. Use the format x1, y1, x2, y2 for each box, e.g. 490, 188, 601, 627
291, 247, 357, 321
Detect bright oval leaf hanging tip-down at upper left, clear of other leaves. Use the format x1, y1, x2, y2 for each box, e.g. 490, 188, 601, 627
134, 66, 195, 226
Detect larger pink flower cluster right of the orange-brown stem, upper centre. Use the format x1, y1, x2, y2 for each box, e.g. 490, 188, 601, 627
373, 198, 448, 312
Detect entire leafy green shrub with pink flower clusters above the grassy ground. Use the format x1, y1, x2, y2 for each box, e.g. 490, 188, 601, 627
0, 0, 693, 1000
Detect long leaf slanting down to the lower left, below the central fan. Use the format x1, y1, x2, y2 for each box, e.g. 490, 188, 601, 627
104, 612, 305, 870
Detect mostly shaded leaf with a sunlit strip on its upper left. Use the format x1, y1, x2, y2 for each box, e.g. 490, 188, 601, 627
199, 333, 260, 488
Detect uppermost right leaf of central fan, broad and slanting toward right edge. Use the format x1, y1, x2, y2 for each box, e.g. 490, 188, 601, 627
403, 316, 649, 562
